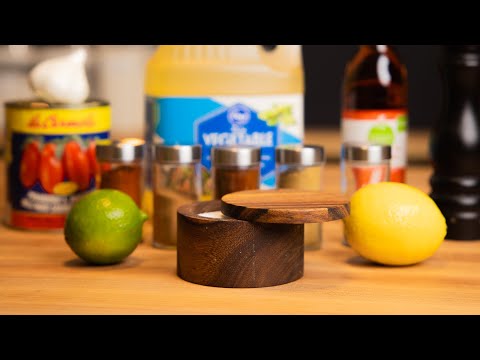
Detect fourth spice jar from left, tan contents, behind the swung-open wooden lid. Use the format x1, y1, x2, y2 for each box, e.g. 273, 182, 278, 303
275, 145, 326, 250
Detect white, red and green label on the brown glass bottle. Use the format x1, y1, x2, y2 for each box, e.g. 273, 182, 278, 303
342, 110, 408, 182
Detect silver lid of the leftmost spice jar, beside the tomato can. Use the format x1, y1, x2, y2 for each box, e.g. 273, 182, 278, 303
96, 138, 145, 162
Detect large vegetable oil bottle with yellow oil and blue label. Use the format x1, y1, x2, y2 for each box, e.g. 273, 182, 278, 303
145, 45, 304, 199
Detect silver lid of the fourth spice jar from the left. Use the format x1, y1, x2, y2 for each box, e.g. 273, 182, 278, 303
275, 144, 326, 166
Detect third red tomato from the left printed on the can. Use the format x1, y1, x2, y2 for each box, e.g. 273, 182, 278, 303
62, 140, 90, 190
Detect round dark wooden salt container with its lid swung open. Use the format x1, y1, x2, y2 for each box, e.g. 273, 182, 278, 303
177, 190, 348, 288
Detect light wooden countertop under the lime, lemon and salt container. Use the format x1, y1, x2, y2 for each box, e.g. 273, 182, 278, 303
0, 130, 480, 314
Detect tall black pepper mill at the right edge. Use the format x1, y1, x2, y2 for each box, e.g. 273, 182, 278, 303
430, 45, 480, 240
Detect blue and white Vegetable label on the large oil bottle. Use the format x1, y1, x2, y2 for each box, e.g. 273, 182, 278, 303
146, 94, 304, 197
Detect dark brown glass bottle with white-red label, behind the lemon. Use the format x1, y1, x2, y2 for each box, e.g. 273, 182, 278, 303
341, 45, 408, 182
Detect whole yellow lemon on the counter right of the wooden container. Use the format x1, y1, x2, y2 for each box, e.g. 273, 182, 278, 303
344, 182, 447, 265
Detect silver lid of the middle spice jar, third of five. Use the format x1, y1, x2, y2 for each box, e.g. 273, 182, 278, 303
211, 145, 261, 166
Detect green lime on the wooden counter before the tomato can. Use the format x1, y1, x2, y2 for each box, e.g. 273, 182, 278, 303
64, 189, 147, 265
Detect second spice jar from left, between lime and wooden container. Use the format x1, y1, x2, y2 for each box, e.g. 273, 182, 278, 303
153, 144, 202, 249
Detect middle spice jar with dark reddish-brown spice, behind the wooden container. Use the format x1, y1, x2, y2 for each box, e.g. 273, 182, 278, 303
211, 146, 260, 199
